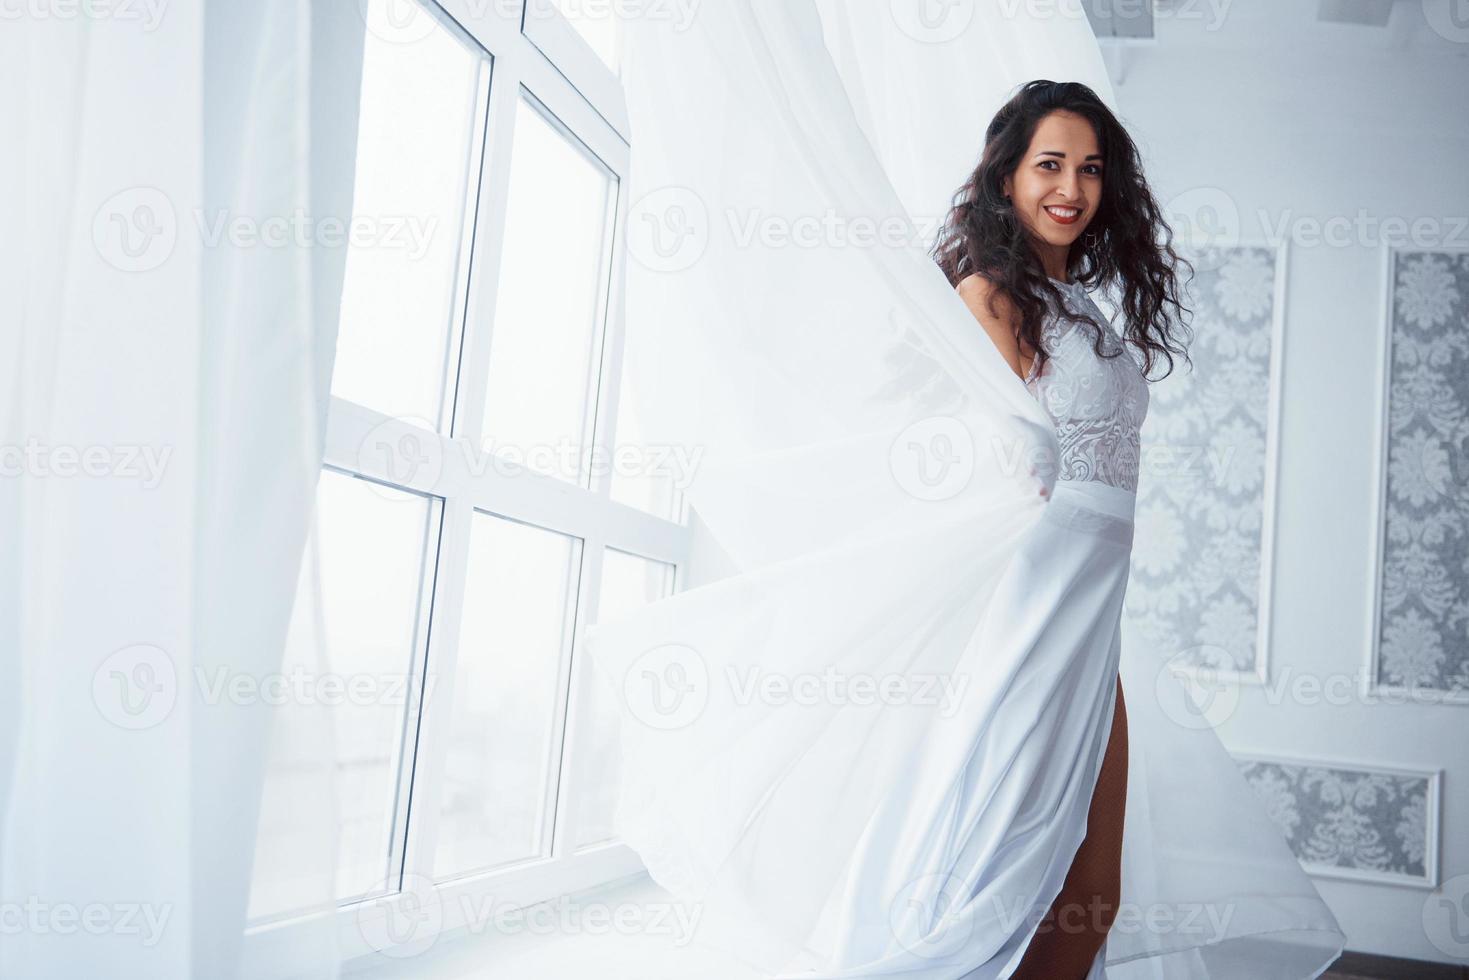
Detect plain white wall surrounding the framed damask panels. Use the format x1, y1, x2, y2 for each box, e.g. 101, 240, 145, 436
1109, 0, 1469, 962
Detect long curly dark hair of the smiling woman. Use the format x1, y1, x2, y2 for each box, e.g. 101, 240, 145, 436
930, 79, 1193, 381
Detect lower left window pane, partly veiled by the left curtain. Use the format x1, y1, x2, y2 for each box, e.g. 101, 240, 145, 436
250, 470, 439, 918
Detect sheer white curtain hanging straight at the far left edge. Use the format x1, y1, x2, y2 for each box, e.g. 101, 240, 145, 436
0, 0, 364, 979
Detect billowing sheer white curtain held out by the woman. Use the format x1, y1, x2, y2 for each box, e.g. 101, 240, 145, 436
588, 0, 1343, 980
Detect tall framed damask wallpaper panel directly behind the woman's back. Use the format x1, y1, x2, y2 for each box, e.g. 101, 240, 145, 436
1127, 247, 1278, 674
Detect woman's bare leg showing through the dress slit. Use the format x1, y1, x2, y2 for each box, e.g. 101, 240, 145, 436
1012, 677, 1127, 980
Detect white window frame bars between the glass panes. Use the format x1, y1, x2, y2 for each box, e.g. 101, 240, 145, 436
247, 0, 692, 965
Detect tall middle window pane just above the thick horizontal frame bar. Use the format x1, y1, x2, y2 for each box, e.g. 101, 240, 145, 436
483, 101, 614, 486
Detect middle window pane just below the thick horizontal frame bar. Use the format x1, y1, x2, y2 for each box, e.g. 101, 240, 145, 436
435, 513, 582, 879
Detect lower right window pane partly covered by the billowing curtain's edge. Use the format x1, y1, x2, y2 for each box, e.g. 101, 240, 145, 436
570, 548, 673, 849
